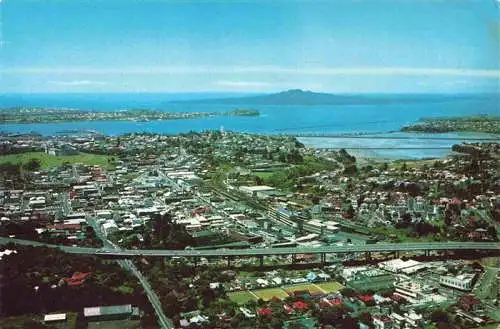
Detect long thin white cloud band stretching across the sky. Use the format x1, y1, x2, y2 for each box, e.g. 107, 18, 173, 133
0, 66, 500, 81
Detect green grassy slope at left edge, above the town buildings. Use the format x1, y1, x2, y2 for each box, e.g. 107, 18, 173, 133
0, 152, 112, 169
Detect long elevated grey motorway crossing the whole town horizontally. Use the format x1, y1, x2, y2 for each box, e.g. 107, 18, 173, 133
0, 237, 500, 258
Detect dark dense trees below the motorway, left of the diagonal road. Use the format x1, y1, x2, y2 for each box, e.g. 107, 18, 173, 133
0, 244, 150, 316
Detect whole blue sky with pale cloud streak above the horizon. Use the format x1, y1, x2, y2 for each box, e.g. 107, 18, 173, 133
0, 0, 500, 93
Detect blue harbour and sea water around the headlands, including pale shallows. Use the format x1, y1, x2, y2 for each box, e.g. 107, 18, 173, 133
0, 93, 500, 158
